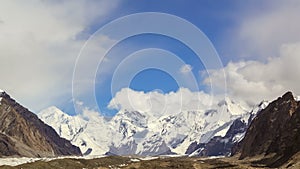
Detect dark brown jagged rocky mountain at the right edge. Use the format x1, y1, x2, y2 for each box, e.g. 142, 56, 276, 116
235, 92, 300, 167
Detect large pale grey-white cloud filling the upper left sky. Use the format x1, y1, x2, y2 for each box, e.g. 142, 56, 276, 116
0, 0, 117, 111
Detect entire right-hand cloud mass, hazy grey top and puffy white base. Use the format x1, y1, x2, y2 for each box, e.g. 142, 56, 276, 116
212, 0, 300, 104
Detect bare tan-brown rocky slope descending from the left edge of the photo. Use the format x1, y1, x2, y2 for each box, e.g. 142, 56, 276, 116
0, 92, 81, 157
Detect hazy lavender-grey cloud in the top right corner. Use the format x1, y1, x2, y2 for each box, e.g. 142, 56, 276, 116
233, 0, 300, 58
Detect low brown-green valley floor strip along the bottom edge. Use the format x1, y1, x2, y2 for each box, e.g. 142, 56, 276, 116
0, 156, 299, 169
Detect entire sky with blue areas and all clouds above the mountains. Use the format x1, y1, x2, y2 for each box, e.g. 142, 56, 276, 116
0, 0, 300, 116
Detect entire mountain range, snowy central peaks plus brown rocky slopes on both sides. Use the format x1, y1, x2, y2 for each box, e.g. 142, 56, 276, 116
0, 88, 300, 168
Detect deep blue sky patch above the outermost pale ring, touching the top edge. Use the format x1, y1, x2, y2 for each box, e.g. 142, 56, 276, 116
87, 0, 240, 62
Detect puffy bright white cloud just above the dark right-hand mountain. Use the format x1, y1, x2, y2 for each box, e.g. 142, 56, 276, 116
204, 43, 300, 104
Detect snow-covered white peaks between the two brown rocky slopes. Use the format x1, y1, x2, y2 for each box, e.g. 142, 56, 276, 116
38, 98, 266, 156
